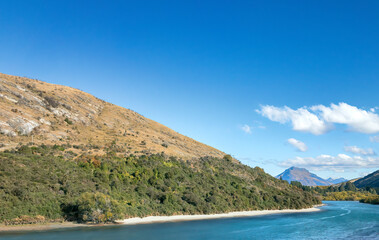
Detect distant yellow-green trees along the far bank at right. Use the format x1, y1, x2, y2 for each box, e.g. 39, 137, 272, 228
291, 181, 379, 204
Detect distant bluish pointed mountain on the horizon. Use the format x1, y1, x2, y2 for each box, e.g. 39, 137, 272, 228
276, 167, 346, 186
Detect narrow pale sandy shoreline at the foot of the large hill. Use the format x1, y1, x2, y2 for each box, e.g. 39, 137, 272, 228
0, 205, 322, 233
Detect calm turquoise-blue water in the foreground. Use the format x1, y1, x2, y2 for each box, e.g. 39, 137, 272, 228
0, 201, 379, 240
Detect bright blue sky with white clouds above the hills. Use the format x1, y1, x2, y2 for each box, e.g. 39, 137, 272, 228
0, 0, 379, 178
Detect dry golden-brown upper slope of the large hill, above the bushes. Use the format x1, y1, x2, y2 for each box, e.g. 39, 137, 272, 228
0, 73, 224, 159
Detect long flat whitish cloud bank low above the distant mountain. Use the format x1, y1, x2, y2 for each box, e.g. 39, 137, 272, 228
279, 154, 379, 172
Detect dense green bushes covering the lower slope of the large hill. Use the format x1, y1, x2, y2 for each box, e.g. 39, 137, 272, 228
0, 145, 320, 224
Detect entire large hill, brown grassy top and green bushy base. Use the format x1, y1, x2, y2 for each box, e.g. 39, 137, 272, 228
0, 74, 320, 224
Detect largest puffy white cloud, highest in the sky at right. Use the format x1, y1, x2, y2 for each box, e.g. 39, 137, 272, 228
257, 103, 379, 135
